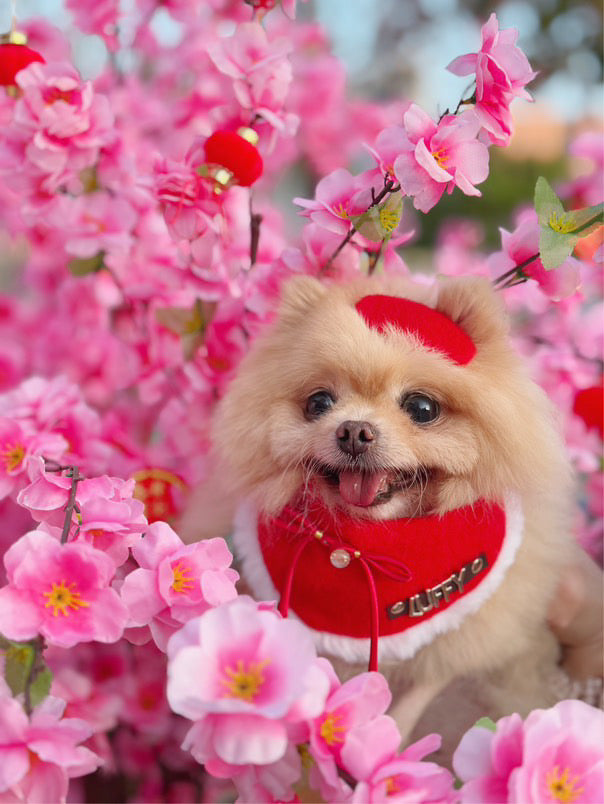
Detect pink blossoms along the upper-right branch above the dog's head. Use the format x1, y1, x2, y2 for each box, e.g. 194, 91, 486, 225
295, 14, 536, 223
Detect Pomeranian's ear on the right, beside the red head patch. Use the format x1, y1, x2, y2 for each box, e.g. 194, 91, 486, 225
436, 277, 508, 348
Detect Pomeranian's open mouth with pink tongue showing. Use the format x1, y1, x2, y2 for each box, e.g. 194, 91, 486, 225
317, 465, 430, 508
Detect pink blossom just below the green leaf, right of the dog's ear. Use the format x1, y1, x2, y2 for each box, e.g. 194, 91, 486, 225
488, 210, 580, 301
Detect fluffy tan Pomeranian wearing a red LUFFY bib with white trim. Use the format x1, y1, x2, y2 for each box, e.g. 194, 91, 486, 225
181, 277, 572, 734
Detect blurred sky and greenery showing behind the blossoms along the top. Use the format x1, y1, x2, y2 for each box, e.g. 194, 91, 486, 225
0, 0, 604, 250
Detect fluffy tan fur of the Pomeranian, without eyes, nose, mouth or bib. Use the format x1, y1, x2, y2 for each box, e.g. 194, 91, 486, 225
180, 278, 573, 748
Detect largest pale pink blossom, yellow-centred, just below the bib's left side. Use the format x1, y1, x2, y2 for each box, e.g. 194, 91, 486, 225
168, 597, 329, 768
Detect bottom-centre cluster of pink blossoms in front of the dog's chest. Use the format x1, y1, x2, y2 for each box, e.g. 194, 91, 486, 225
168, 597, 453, 802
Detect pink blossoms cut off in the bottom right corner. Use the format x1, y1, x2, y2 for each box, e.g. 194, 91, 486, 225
453, 700, 604, 804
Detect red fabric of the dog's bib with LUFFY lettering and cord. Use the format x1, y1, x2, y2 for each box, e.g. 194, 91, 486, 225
258, 501, 506, 669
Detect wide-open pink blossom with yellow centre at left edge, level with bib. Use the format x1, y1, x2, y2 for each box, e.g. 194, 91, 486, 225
0, 530, 128, 647
